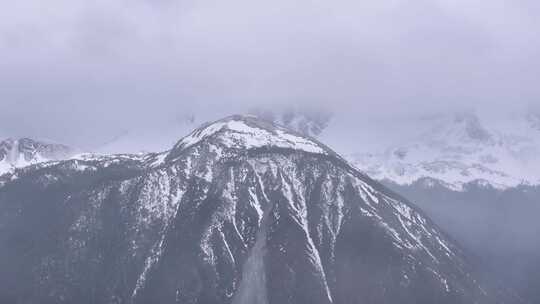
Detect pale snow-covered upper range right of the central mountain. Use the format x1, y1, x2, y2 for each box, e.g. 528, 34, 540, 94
350, 113, 540, 190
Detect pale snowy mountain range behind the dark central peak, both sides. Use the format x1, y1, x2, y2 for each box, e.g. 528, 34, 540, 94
0, 109, 540, 191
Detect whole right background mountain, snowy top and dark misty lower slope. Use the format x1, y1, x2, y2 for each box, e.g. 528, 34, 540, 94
351, 112, 540, 303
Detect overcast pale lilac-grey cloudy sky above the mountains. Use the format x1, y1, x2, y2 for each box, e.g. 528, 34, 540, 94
0, 0, 540, 150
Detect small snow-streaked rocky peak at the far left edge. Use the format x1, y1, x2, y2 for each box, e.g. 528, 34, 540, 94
0, 138, 76, 175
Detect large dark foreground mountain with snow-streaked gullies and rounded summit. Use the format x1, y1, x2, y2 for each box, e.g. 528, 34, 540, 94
0, 116, 518, 304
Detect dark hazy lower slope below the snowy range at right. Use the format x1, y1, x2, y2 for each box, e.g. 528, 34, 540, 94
385, 178, 540, 303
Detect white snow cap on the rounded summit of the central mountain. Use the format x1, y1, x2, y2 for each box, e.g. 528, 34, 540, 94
176, 116, 326, 154
